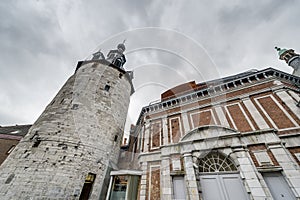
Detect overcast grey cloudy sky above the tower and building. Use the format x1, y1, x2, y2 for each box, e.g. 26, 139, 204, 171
0, 0, 300, 136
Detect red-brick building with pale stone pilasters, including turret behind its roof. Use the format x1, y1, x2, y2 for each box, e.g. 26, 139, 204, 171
107, 48, 300, 200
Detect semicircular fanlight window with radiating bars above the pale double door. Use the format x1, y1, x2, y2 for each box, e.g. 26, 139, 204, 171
198, 152, 237, 172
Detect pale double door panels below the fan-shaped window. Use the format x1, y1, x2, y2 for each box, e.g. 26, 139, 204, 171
200, 174, 249, 200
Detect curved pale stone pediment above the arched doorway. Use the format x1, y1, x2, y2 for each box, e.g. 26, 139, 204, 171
179, 125, 240, 142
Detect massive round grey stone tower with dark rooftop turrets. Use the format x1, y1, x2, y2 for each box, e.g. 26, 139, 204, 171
0, 44, 134, 200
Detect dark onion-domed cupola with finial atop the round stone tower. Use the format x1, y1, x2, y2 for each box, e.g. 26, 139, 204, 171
106, 40, 126, 69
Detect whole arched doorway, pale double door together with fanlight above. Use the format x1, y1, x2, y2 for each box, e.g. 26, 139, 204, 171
197, 152, 249, 200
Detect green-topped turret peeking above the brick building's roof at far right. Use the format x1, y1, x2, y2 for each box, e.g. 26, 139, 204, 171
275, 47, 300, 76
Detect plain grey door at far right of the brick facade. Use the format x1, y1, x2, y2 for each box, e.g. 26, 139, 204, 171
263, 172, 296, 200
